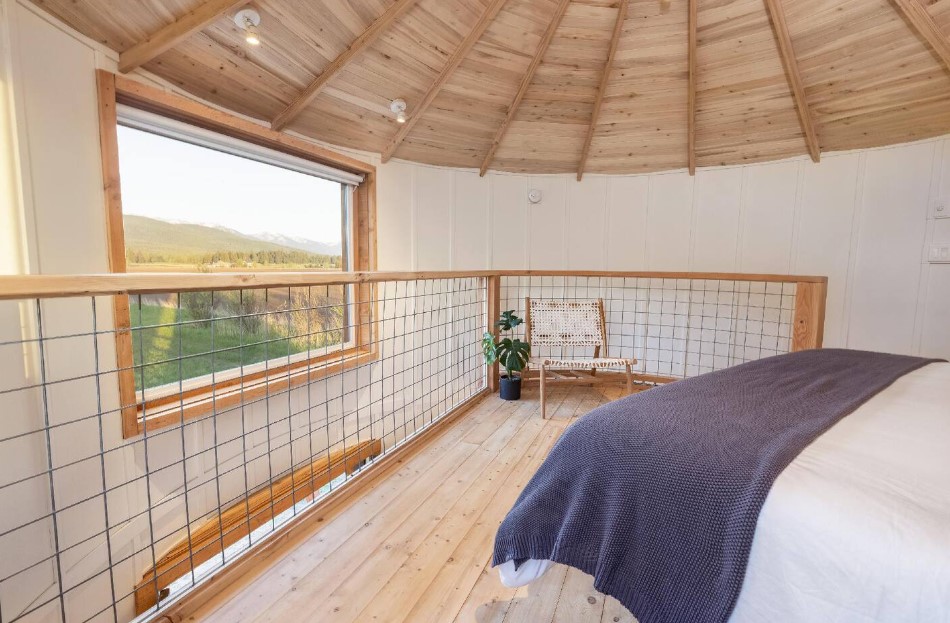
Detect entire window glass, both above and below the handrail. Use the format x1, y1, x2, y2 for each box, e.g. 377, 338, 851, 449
119, 126, 349, 391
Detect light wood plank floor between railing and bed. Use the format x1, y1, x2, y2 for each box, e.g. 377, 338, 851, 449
191, 388, 635, 623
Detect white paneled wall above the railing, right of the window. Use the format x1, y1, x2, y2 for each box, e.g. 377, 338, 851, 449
379, 147, 950, 357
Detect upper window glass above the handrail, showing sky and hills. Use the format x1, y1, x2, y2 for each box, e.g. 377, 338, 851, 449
118, 126, 344, 272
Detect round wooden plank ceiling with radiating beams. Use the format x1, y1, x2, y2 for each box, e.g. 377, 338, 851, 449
34, 0, 950, 177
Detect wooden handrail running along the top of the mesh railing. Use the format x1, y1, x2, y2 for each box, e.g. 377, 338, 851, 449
0, 270, 828, 301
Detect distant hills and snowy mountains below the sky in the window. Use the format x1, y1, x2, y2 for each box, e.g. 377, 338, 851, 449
122, 214, 339, 256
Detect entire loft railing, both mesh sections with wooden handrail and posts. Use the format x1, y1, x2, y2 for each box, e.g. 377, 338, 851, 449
0, 271, 824, 623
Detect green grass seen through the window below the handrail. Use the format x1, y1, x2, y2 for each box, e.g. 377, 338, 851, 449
131, 304, 338, 389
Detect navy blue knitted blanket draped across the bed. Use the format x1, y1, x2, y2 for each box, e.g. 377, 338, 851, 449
493, 349, 934, 623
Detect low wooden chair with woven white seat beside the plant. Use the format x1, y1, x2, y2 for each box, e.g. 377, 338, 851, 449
525, 298, 637, 419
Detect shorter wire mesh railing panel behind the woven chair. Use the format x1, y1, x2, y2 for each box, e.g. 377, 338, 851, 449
500, 275, 798, 378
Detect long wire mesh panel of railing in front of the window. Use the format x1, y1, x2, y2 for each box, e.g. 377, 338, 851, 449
0, 277, 486, 623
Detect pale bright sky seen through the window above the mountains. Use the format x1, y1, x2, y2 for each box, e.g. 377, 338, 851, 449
119, 126, 341, 243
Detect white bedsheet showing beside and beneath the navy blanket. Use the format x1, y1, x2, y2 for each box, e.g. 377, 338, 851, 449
499, 363, 950, 623
